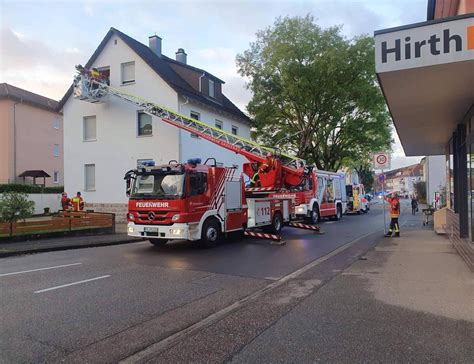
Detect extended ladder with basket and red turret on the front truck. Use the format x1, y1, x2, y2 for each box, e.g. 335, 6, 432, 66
74, 69, 311, 191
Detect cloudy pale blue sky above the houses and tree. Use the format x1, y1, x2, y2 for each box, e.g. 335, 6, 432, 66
0, 0, 427, 168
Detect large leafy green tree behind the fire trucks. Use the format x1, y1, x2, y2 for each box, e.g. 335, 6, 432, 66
237, 15, 391, 171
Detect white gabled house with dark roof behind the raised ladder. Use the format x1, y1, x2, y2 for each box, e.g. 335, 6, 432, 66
58, 28, 251, 221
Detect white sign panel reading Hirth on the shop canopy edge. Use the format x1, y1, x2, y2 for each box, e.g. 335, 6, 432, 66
375, 14, 474, 73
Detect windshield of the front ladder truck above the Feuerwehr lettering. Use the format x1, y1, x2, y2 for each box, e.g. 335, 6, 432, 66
130, 173, 184, 199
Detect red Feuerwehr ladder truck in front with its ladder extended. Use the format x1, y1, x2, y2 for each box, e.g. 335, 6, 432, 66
73, 71, 319, 247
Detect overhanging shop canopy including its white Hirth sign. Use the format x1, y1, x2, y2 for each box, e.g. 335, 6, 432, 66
375, 14, 474, 156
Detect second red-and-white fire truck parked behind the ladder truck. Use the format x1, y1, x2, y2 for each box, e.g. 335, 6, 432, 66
296, 170, 347, 224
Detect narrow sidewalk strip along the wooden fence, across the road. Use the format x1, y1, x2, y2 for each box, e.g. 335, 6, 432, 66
0, 233, 141, 258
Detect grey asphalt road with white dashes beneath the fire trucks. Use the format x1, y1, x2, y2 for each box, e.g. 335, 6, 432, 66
0, 200, 383, 363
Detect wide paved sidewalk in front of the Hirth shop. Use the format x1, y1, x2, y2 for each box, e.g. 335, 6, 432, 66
232, 228, 474, 363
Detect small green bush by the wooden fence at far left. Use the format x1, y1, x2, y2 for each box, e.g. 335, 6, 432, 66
0, 192, 35, 223
